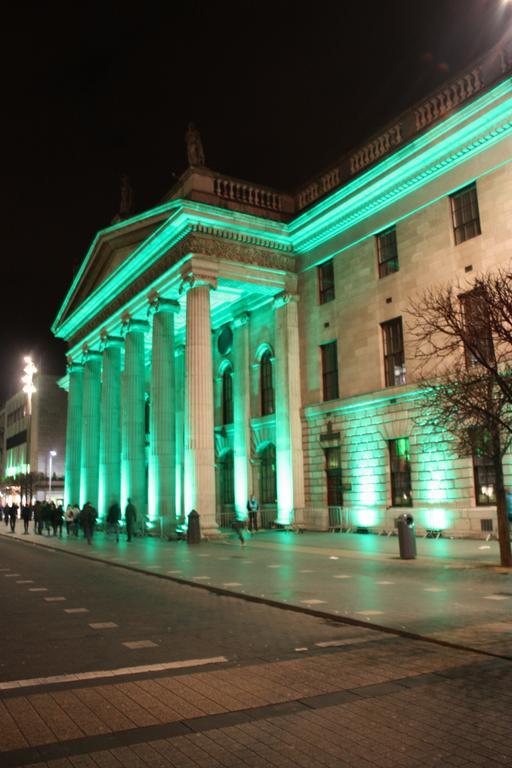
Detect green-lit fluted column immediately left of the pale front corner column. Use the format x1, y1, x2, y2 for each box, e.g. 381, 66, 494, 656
148, 298, 180, 536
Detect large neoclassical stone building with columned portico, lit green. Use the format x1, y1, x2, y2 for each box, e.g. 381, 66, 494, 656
53, 44, 512, 535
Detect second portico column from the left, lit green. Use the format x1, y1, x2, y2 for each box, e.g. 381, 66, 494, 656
80, 350, 101, 509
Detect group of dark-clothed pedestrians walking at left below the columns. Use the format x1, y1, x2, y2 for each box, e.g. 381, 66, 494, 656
0, 499, 137, 544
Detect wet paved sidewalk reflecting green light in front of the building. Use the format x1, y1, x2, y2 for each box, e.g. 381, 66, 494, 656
0, 528, 512, 657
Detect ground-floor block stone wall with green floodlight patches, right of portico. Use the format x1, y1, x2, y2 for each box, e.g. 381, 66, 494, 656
303, 388, 506, 536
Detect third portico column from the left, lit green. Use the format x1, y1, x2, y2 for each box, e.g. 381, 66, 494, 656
98, 336, 123, 517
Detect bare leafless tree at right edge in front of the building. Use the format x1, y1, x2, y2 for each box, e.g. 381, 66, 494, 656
408, 269, 512, 566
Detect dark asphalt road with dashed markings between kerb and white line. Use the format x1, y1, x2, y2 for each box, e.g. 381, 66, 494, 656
0, 540, 368, 682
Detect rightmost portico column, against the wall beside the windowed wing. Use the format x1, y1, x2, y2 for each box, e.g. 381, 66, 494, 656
274, 293, 304, 525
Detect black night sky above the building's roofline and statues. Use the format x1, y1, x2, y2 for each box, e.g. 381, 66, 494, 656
0, 0, 512, 397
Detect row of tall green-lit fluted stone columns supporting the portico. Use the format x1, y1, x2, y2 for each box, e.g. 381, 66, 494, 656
65, 277, 304, 534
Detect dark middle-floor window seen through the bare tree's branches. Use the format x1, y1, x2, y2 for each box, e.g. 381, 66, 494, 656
459, 289, 495, 368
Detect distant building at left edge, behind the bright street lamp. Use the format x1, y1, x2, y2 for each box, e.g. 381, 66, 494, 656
0, 373, 67, 499
